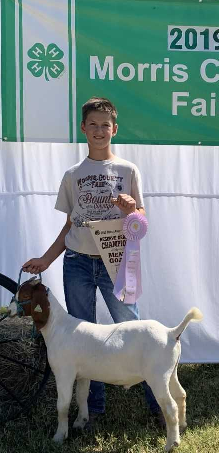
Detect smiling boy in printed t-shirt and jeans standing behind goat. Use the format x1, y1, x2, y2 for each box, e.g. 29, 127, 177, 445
23, 97, 163, 426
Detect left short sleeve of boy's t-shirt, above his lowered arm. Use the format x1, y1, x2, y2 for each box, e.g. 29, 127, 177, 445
55, 173, 73, 215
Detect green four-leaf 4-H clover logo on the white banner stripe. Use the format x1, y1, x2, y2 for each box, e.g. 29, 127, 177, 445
27, 42, 65, 81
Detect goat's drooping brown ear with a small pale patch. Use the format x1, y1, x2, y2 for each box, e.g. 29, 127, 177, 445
31, 283, 50, 331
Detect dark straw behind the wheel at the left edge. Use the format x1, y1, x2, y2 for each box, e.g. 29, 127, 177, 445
0, 318, 46, 420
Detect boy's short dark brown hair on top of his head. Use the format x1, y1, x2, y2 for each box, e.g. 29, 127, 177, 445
82, 96, 118, 124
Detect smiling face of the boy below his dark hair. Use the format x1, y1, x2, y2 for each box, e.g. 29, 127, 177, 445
81, 111, 118, 150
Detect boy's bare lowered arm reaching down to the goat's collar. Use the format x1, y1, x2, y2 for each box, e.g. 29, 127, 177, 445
22, 215, 72, 274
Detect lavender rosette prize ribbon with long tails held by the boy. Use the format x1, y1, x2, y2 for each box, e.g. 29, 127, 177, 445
113, 212, 148, 304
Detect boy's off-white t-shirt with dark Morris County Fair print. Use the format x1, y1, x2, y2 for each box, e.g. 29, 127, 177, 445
55, 156, 144, 255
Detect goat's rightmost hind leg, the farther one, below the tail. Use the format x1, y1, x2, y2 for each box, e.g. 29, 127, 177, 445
170, 366, 187, 433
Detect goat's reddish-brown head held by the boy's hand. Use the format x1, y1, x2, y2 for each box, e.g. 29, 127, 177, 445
9, 279, 50, 330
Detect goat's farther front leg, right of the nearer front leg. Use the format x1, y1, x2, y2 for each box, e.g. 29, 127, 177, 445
73, 379, 90, 429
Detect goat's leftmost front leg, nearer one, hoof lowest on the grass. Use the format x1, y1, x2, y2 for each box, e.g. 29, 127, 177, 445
53, 369, 75, 443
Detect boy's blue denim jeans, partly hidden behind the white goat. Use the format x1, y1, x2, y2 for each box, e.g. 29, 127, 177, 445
63, 249, 159, 413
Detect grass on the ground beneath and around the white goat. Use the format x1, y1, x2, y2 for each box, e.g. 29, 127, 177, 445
0, 364, 219, 453
